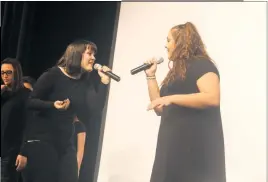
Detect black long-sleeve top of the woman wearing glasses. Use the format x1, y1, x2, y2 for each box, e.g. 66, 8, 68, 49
1, 87, 30, 157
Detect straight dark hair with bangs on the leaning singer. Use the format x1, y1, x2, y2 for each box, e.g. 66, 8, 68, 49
56, 40, 97, 76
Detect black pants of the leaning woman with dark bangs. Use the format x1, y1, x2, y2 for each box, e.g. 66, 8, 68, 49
22, 142, 78, 182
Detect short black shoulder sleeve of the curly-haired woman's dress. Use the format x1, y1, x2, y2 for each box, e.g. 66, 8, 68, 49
190, 60, 220, 81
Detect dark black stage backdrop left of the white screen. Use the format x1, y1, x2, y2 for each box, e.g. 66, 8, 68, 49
1, 2, 120, 182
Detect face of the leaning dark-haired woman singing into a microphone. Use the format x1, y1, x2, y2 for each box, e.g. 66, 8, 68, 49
81, 47, 96, 72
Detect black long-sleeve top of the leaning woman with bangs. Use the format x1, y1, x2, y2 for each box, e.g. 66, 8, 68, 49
22, 67, 107, 155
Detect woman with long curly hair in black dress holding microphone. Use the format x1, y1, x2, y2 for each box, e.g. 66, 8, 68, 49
145, 22, 226, 182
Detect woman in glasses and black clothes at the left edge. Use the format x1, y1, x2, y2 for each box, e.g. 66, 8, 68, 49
1, 58, 30, 182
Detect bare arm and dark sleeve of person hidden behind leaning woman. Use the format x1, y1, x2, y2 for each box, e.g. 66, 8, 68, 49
73, 117, 86, 176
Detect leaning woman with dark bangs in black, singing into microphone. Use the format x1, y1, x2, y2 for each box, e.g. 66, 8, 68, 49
22, 41, 110, 182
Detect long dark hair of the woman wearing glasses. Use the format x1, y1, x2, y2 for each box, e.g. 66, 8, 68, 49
1, 58, 23, 92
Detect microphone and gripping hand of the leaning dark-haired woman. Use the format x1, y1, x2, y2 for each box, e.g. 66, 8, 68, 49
94, 63, 120, 84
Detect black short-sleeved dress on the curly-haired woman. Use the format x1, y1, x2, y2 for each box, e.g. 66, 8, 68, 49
151, 60, 226, 182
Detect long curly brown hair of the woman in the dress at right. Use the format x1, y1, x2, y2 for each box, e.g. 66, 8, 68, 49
162, 22, 212, 85
